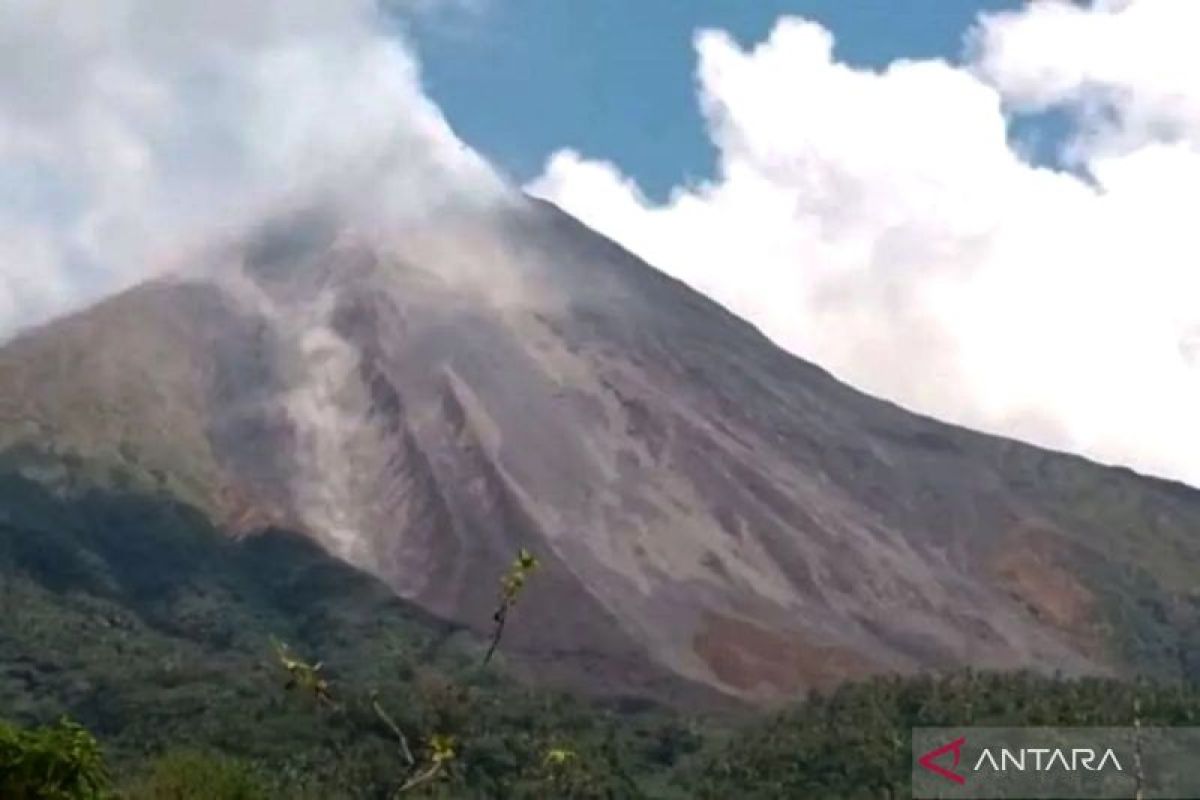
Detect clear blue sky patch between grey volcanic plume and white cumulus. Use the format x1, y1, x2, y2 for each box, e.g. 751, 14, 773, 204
413, 0, 1021, 198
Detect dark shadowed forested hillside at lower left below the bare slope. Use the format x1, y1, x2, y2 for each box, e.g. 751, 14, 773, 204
0, 470, 683, 798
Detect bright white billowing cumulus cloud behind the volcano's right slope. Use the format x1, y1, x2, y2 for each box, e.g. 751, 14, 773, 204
527, 0, 1200, 486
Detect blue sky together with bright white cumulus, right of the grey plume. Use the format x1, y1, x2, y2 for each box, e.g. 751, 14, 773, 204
413, 0, 1200, 482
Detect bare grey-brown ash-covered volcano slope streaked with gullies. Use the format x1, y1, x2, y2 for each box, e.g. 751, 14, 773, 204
0, 196, 1200, 702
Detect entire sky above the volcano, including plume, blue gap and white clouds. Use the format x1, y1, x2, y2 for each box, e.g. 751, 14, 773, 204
0, 0, 1200, 486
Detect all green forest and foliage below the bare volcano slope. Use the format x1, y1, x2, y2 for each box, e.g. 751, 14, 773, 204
7, 460, 1200, 800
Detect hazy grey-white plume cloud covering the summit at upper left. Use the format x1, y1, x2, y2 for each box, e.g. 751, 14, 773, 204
0, 0, 499, 336
